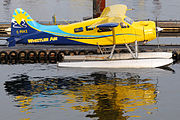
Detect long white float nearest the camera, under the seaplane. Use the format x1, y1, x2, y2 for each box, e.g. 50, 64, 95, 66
58, 59, 173, 68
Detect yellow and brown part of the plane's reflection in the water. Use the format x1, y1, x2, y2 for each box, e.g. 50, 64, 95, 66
65, 78, 157, 120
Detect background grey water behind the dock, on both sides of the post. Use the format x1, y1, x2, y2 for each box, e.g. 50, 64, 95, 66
0, 0, 180, 22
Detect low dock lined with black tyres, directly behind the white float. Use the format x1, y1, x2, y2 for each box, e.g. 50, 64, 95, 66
0, 45, 180, 64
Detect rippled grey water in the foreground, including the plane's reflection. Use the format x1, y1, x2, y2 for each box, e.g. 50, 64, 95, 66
0, 64, 180, 120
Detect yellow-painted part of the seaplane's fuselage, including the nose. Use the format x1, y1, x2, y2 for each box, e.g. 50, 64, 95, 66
58, 18, 156, 45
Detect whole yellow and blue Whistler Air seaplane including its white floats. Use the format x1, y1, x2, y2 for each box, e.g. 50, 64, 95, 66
8, 4, 173, 68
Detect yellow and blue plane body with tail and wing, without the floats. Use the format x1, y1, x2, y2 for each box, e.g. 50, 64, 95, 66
8, 4, 156, 46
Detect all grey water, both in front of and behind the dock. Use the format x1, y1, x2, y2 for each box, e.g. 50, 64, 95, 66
0, 0, 180, 120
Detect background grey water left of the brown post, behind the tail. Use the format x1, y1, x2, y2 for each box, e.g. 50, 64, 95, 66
0, 0, 92, 22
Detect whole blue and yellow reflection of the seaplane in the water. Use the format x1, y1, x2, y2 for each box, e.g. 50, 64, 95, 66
5, 72, 157, 120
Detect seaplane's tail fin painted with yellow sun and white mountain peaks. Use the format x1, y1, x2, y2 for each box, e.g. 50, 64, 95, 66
8, 8, 40, 46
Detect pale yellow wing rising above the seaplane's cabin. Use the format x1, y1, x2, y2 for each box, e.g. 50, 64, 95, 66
90, 4, 127, 28
